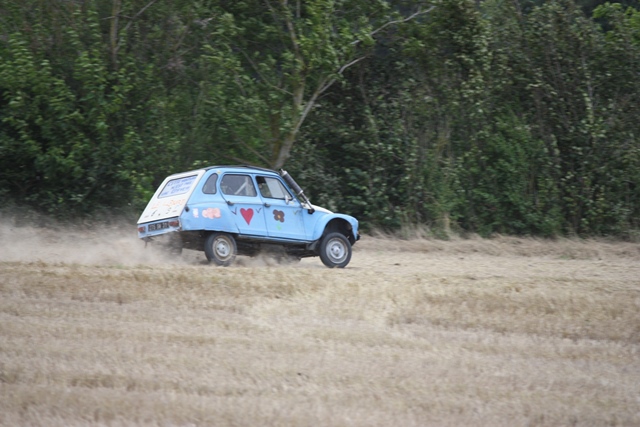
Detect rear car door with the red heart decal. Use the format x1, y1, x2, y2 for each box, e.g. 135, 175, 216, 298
220, 173, 268, 237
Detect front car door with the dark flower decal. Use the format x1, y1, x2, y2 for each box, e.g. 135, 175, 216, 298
256, 175, 307, 240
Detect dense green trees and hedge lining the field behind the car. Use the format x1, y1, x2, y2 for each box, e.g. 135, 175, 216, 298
0, 0, 640, 238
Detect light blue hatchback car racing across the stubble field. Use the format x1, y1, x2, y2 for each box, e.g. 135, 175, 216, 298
138, 166, 360, 268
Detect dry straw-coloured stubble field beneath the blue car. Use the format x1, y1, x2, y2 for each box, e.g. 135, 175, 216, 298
0, 225, 640, 426
